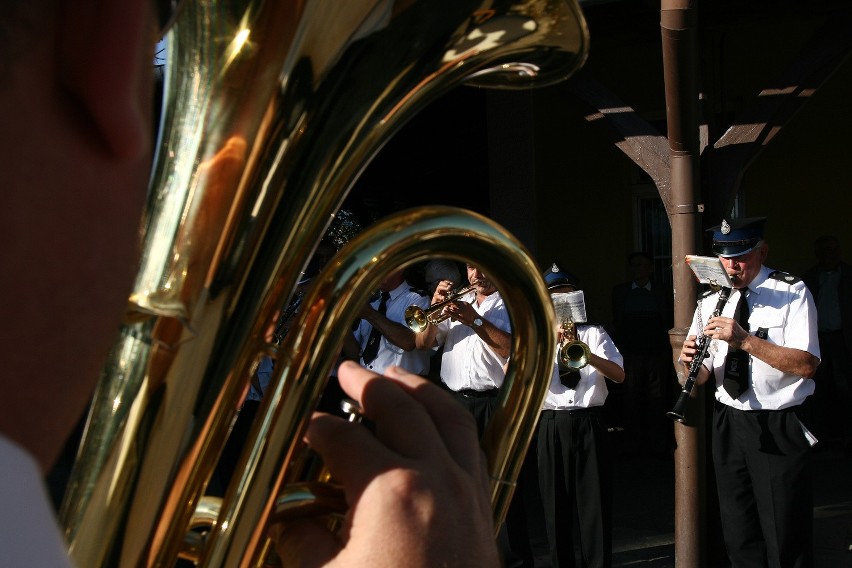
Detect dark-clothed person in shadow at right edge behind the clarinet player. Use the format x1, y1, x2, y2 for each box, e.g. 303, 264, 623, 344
802, 235, 852, 456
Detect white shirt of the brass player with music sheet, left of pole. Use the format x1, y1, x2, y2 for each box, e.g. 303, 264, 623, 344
542, 324, 624, 410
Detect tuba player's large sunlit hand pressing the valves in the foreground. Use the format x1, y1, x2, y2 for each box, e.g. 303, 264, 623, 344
273, 362, 499, 568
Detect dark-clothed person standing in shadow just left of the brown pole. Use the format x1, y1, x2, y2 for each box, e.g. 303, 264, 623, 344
608, 251, 678, 456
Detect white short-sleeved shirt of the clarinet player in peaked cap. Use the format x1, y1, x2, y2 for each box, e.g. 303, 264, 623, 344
688, 266, 820, 410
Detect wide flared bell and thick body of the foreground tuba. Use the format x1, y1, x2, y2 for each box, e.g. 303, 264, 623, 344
59, 0, 588, 567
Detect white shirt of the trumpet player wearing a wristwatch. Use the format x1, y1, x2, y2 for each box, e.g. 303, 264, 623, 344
436, 292, 512, 391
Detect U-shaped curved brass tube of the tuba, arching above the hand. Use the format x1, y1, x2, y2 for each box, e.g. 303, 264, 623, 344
207, 207, 555, 566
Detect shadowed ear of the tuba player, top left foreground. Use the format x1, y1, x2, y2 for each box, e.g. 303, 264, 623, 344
57, 0, 158, 158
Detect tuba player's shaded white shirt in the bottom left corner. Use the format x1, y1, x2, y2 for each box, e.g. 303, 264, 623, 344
0, 436, 72, 568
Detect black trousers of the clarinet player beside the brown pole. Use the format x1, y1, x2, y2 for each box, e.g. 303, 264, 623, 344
712, 402, 813, 568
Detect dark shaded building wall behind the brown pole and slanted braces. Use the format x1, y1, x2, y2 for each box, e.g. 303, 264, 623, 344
516, 3, 852, 321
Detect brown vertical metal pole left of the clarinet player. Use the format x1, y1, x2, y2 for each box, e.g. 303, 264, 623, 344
660, 0, 706, 568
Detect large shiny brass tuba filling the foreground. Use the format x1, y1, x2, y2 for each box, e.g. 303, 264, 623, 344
60, 0, 588, 567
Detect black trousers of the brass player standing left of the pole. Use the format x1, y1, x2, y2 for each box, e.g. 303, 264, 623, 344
538, 407, 612, 568
